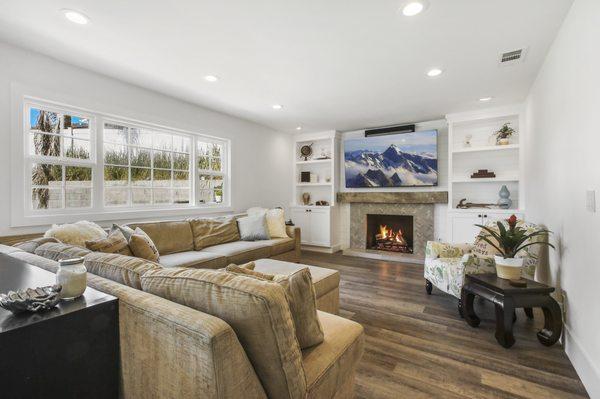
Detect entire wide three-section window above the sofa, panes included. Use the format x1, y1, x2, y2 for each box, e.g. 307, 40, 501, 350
18, 96, 230, 226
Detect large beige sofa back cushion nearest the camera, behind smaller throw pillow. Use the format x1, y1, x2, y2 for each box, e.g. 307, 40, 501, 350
142, 268, 306, 398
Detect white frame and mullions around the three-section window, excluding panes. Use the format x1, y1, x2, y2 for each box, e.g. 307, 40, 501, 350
10, 91, 232, 227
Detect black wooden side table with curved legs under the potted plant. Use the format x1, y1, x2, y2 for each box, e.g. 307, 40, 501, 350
461, 273, 562, 348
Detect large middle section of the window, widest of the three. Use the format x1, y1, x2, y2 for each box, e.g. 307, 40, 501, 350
103, 122, 191, 206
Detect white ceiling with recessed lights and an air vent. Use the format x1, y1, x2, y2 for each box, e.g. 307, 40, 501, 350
0, 0, 572, 132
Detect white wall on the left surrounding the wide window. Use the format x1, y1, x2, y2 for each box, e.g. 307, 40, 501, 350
0, 42, 292, 236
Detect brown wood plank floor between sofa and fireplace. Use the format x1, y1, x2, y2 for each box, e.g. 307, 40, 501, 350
301, 251, 588, 399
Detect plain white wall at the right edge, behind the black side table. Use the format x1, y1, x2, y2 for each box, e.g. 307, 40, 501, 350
525, 0, 600, 398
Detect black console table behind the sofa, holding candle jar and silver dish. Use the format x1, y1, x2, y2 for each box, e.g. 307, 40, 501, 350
0, 254, 119, 398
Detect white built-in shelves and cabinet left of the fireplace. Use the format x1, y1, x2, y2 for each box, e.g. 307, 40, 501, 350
291, 131, 340, 252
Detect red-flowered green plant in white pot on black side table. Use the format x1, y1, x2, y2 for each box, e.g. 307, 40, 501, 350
476, 215, 554, 280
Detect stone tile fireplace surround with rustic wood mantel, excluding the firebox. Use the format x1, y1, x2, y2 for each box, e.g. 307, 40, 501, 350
338, 191, 448, 263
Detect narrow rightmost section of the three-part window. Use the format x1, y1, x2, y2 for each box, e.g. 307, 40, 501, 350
196, 140, 226, 204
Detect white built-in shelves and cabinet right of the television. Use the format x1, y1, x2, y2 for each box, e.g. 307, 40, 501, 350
446, 105, 526, 242
